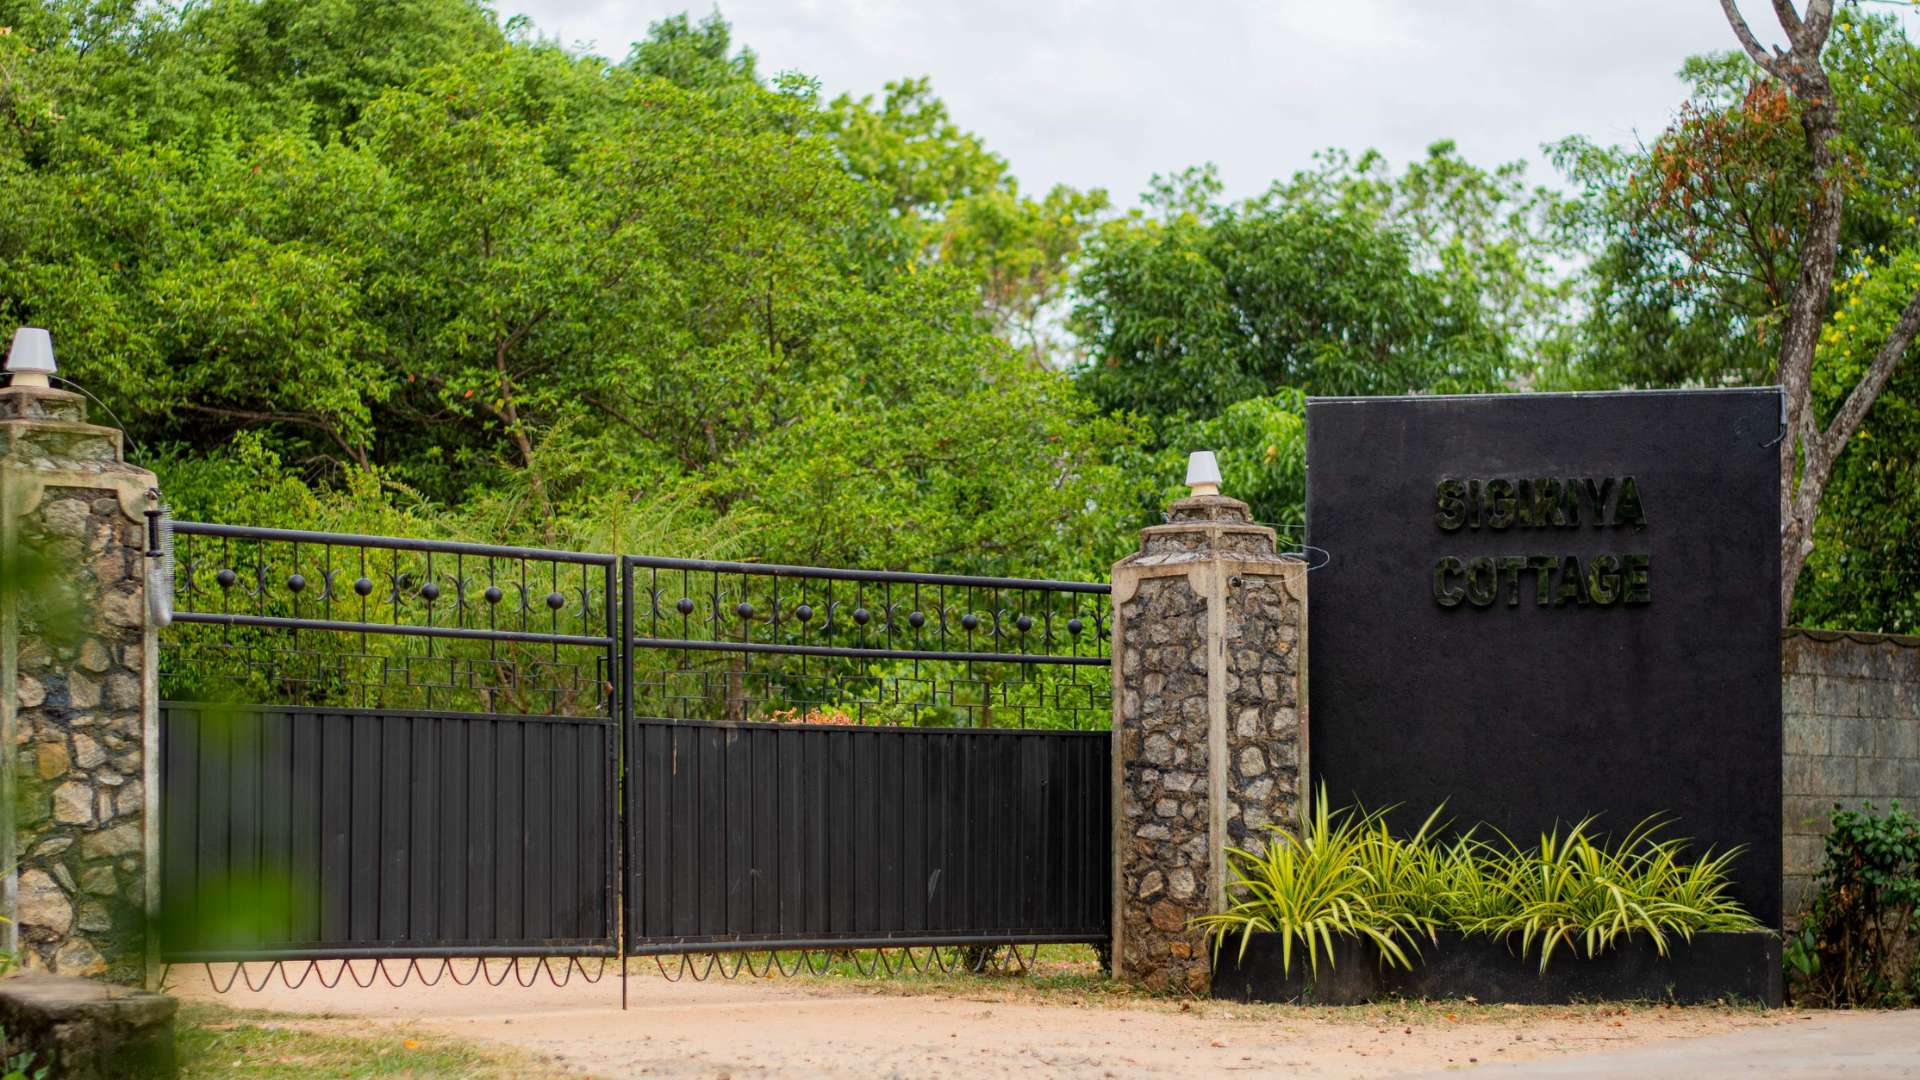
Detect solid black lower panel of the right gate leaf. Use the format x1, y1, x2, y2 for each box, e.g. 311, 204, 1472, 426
626, 721, 1108, 955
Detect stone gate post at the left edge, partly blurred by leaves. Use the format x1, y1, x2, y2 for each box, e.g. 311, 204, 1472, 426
0, 329, 157, 982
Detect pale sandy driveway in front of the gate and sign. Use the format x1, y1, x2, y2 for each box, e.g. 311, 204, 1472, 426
169, 953, 1920, 1080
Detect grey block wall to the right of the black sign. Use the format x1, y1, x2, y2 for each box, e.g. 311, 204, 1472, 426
1780, 628, 1920, 920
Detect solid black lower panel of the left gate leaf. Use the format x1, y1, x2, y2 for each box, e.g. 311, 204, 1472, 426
161, 703, 614, 961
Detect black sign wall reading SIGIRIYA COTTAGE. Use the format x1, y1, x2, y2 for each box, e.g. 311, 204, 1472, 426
1308, 390, 1780, 924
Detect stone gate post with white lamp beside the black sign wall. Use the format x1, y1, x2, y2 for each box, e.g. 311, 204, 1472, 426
1114, 452, 1308, 994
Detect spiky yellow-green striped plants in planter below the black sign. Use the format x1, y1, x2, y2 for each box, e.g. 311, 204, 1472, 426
1194, 792, 1759, 970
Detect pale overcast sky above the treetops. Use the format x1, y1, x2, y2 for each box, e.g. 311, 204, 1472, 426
499, 0, 1904, 206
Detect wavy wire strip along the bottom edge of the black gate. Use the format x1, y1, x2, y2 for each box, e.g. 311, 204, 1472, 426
176, 945, 1041, 1007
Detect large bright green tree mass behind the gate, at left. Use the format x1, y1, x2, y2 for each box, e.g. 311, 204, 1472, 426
0, 0, 1137, 573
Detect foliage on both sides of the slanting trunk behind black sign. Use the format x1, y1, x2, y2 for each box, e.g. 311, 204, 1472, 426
1542, 8, 1920, 632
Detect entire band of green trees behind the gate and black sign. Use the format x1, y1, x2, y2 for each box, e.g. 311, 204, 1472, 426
0, 0, 1920, 630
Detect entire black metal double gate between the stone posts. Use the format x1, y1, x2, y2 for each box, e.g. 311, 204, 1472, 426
159, 523, 1110, 982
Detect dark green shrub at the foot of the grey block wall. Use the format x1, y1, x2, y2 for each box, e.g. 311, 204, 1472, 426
1786, 803, 1920, 1007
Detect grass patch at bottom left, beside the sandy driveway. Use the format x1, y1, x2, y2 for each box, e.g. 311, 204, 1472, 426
175, 1005, 557, 1078
